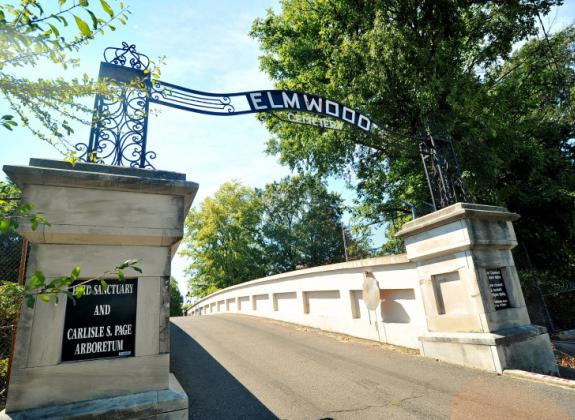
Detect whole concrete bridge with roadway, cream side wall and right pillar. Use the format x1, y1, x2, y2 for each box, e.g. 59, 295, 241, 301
180, 204, 575, 419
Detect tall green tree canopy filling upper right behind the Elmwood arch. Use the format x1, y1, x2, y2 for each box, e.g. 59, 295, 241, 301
252, 0, 575, 276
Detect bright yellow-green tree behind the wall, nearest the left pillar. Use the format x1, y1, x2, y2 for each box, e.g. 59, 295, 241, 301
181, 181, 266, 296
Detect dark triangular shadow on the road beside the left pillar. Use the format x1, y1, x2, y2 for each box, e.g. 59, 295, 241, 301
170, 323, 277, 419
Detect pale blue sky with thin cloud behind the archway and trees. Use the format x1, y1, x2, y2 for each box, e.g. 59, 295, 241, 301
0, 0, 575, 293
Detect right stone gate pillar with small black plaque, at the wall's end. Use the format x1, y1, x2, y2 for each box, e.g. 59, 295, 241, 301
397, 203, 558, 374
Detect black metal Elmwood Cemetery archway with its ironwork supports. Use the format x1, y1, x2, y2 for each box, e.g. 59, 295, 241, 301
75, 42, 466, 210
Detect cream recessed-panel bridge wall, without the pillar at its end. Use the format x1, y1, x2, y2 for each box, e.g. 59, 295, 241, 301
188, 255, 426, 348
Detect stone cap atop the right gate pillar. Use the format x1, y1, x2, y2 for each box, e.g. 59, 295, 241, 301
396, 203, 519, 260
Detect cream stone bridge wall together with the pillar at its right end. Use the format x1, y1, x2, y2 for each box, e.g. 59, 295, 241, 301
189, 203, 558, 374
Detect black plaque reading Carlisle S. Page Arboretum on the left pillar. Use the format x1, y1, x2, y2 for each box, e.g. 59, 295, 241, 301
62, 279, 138, 361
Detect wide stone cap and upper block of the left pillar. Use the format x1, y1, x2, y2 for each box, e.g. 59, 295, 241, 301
3, 159, 198, 246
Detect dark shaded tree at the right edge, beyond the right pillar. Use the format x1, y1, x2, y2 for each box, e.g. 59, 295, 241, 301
488, 27, 575, 328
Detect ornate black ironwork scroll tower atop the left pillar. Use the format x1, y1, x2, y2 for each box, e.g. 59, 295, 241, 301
75, 42, 156, 169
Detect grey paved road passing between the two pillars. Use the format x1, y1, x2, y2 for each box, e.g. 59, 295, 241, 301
172, 315, 575, 420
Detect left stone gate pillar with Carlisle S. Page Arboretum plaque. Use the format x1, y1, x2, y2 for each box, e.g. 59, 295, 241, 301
4, 159, 198, 418
